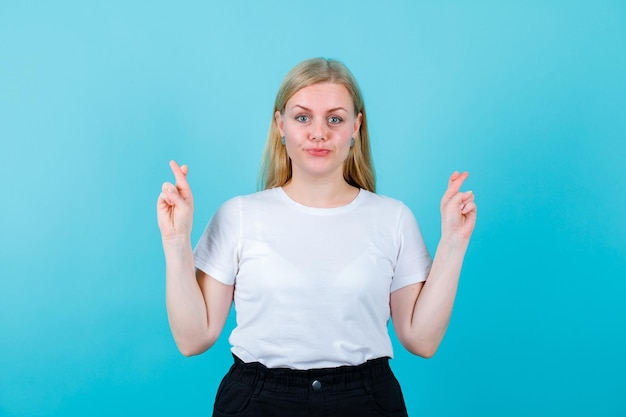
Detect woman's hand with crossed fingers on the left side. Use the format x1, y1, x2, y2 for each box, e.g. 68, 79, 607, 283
157, 161, 193, 241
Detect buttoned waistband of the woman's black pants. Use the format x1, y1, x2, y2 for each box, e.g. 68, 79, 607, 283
229, 355, 393, 393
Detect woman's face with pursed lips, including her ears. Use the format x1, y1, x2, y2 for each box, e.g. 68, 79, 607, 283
275, 83, 362, 183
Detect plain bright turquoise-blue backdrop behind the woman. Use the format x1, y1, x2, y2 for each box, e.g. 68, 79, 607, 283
0, 0, 626, 417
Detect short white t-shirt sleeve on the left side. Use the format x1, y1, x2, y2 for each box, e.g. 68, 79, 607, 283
193, 197, 241, 285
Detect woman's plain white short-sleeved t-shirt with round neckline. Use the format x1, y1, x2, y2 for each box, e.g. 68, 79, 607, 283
194, 187, 431, 369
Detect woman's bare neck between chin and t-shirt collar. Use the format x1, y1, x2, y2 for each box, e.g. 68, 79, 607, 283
283, 178, 359, 208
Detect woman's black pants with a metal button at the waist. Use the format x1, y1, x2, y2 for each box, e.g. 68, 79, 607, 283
213, 357, 407, 417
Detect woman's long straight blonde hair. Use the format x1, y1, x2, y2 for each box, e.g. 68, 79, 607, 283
259, 58, 376, 192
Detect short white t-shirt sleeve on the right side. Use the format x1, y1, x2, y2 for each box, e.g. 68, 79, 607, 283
391, 204, 432, 292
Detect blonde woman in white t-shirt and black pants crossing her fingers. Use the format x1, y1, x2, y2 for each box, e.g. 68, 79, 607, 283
157, 59, 476, 417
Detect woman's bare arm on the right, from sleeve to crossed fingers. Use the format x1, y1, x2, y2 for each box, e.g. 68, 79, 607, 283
390, 172, 476, 358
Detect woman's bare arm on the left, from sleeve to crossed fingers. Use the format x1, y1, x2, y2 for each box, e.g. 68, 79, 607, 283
157, 161, 234, 356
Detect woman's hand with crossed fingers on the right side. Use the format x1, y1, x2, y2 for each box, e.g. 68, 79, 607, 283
441, 171, 476, 240
